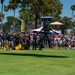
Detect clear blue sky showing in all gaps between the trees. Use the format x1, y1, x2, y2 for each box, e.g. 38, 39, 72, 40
0, 0, 75, 22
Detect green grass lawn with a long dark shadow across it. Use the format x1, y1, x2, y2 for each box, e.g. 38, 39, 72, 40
0, 49, 75, 75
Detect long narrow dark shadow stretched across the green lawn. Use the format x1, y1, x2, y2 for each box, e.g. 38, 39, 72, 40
0, 53, 68, 58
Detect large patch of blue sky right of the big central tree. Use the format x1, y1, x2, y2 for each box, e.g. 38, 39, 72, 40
60, 0, 75, 17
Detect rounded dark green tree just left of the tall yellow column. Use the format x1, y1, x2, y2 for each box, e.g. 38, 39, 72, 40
3, 16, 21, 33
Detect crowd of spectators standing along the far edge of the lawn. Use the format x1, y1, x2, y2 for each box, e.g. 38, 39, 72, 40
0, 32, 75, 50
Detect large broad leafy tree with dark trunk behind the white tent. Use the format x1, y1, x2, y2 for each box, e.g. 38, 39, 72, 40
30, 0, 63, 28
